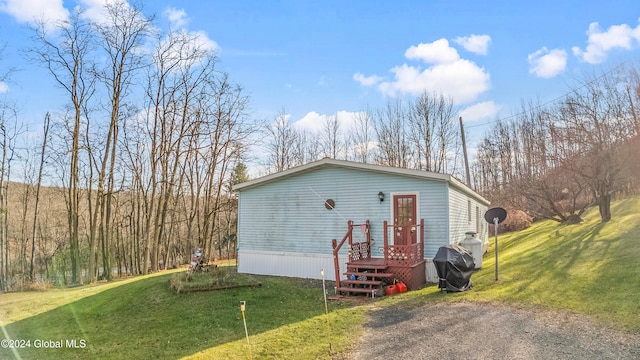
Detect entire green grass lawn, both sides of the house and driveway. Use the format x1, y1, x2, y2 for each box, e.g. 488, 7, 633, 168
0, 198, 640, 360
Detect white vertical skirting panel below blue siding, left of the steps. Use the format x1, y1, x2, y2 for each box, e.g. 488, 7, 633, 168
238, 250, 347, 281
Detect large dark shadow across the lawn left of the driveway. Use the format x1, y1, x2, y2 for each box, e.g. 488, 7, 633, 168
0, 274, 348, 359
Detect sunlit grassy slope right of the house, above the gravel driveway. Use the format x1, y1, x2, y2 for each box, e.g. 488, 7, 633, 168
400, 198, 640, 332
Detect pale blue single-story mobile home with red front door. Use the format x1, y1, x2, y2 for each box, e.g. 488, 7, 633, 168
234, 159, 489, 282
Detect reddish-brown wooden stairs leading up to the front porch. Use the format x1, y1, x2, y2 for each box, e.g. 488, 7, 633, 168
336, 259, 394, 298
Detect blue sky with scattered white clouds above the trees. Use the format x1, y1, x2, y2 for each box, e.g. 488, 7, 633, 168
0, 0, 640, 146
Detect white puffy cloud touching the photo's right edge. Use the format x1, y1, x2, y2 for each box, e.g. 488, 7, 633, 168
571, 22, 640, 64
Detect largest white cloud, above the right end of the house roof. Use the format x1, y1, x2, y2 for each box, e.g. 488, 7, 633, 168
353, 39, 490, 104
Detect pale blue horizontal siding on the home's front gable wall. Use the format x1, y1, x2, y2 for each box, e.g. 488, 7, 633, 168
238, 168, 448, 272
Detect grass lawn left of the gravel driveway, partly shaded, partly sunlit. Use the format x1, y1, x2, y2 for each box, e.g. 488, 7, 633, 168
0, 266, 363, 359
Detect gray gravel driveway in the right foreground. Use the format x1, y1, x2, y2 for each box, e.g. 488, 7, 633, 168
352, 303, 640, 360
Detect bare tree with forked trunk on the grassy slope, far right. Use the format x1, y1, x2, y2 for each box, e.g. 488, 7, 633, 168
555, 69, 635, 222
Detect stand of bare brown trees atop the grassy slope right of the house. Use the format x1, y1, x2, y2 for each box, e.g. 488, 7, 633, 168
476, 69, 638, 222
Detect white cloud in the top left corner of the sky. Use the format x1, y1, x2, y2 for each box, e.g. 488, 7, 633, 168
0, 0, 69, 30
